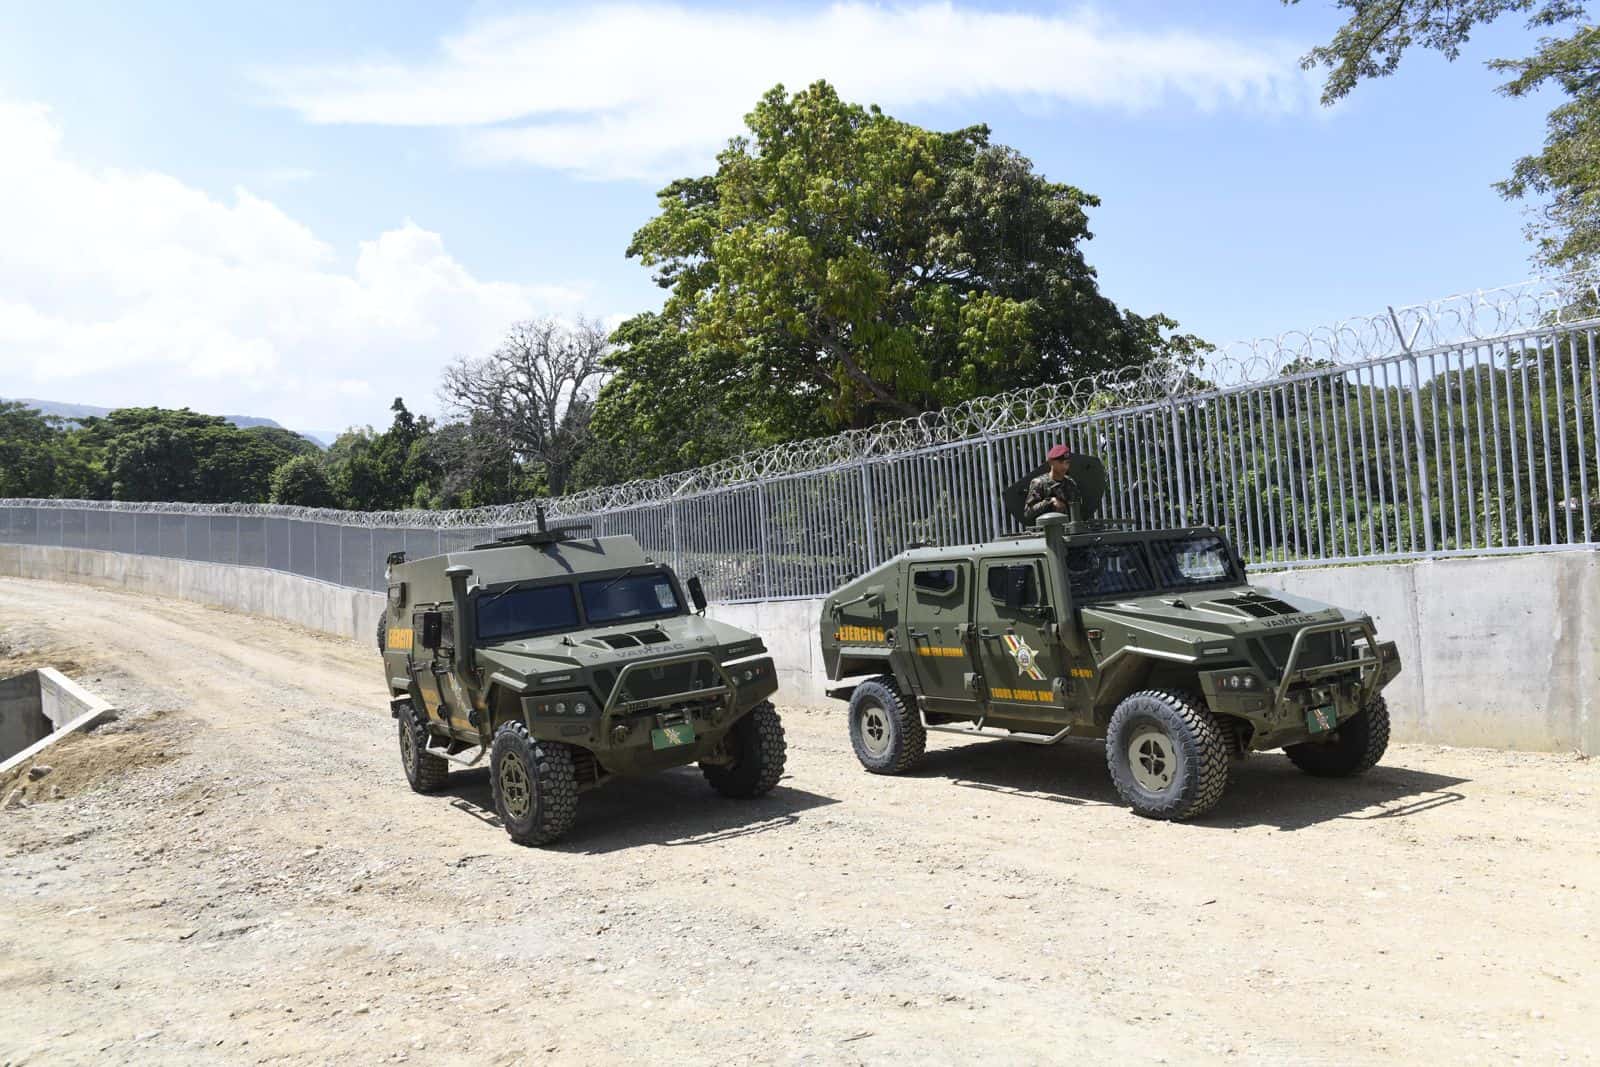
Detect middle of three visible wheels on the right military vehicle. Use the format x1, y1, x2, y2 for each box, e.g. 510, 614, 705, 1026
1106, 689, 1227, 821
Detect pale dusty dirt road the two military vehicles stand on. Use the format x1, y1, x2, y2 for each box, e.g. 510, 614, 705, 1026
0, 579, 1600, 1064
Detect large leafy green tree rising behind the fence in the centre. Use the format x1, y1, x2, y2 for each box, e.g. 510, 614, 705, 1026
624, 82, 1198, 441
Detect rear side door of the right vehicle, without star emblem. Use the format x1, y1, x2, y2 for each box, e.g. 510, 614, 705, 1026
902, 560, 979, 717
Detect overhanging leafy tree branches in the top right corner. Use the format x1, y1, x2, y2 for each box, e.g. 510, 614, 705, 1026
1283, 0, 1600, 270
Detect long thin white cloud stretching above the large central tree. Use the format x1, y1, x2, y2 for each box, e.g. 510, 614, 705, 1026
261, 2, 1315, 178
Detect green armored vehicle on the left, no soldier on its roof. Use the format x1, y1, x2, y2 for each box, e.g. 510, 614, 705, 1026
378, 512, 784, 845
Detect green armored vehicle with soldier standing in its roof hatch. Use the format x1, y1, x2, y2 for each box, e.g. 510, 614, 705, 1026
821, 454, 1400, 819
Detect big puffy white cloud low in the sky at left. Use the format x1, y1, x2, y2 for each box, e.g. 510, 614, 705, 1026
0, 99, 582, 427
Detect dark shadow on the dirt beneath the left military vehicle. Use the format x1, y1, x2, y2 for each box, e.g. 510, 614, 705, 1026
442, 768, 838, 856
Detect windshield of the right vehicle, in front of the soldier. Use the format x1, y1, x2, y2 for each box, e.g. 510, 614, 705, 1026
1066, 534, 1243, 600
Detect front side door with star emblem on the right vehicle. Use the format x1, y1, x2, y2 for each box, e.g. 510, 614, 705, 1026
976, 557, 1064, 718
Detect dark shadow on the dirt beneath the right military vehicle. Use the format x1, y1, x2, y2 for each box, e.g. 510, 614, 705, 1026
914, 741, 1469, 830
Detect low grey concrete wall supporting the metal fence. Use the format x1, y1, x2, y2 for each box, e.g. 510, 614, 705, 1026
0, 544, 1600, 753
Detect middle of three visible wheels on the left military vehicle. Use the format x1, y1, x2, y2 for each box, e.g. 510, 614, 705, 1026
490, 720, 578, 845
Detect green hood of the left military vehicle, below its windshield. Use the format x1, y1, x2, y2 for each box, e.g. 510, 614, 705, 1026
477, 616, 760, 675
